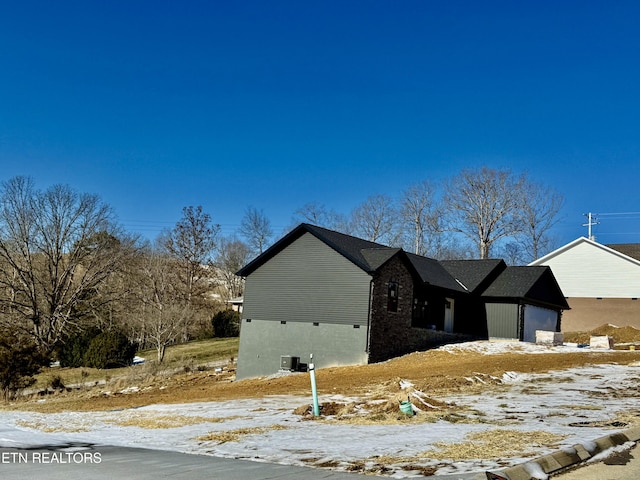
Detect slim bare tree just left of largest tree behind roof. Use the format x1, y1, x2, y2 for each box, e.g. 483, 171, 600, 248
400, 180, 442, 255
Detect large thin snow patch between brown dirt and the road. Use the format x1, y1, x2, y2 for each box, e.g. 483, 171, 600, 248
0, 360, 640, 478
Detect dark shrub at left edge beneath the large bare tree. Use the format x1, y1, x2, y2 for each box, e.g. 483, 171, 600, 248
0, 327, 48, 400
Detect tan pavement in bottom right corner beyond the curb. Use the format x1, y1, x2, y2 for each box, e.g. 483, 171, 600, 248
552, 445, 640, 480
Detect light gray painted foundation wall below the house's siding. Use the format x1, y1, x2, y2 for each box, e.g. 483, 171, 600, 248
236, 320, 368, 379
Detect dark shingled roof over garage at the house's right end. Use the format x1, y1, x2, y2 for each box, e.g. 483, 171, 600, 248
482, 267, 569, 309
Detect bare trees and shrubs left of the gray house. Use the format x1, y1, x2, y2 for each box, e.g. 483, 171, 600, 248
0, 177, 251, 398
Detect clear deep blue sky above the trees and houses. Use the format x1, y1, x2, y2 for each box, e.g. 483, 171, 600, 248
0, 0, 640, 248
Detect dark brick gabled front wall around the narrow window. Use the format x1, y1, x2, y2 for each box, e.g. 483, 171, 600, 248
369, 257, 470, 363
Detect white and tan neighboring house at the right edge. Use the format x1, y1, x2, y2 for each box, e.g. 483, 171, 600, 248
530, 237, 640, 332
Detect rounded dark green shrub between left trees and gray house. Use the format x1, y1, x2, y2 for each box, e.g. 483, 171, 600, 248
84, 330, 137, 368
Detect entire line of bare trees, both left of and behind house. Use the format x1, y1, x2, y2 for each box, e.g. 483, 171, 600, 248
0, 168, 562, 398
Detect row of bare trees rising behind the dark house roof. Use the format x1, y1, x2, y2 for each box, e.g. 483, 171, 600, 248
294, 167, 563, 264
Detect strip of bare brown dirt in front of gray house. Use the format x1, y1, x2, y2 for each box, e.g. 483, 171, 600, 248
5, 326, 640, 412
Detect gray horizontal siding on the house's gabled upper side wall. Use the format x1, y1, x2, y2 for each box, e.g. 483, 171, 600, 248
242, 233, 371, 330
